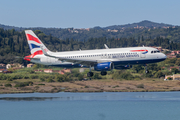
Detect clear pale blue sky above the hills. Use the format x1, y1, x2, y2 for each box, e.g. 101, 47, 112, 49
0, 0, 180, 28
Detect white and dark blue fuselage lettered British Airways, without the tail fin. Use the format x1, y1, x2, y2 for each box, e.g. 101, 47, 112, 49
31, 47, 166, 67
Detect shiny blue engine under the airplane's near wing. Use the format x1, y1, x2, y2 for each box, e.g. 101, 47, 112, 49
94, 62, 114, 71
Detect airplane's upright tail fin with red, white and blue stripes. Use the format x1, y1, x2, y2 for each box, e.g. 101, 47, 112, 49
25, 30, 49, 58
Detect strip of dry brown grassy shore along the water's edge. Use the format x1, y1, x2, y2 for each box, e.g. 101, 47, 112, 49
0, 79, 180, 94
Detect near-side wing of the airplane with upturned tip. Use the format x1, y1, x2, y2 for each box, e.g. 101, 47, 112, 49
40, 46, 100, 65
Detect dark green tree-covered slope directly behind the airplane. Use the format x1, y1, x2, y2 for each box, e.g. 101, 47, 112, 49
0, 28, 180, 64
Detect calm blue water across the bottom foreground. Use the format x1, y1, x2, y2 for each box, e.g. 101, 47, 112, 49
0, 92, 180, 120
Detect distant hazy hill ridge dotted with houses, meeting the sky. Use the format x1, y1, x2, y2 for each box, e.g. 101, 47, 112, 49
0, 20, 180, 42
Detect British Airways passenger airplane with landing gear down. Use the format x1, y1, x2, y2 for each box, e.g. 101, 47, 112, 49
24, 30, 166, 77
